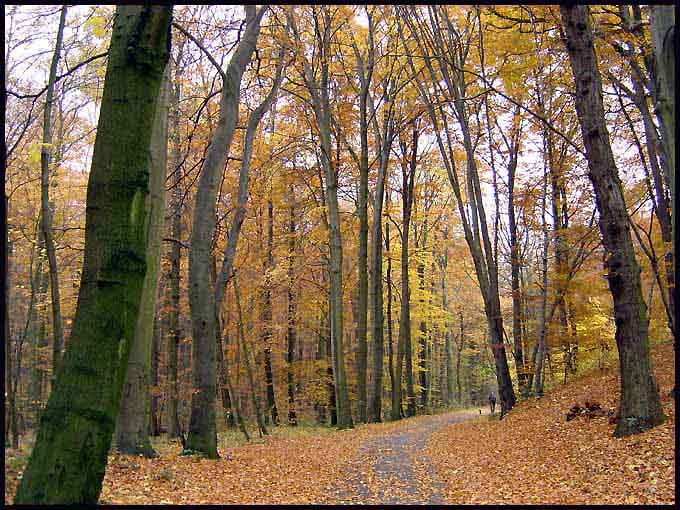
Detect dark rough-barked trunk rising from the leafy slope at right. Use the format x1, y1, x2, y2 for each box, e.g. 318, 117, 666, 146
560, 6, 665, 436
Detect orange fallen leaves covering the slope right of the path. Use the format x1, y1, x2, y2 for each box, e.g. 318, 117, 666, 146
426, 345, 675, 505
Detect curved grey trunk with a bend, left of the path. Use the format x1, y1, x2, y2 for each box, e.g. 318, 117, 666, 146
186, 6, 267, 458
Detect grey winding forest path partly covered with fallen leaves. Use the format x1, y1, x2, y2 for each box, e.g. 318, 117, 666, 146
323, 409, 488, 505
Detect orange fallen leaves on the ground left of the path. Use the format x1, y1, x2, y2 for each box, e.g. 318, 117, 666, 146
100, 431, 358, 505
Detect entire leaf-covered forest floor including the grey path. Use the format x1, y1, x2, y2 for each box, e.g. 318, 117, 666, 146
5, 344, 675, 504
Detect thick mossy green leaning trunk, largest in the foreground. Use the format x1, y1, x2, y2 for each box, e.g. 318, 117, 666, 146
14, 5, 172, 504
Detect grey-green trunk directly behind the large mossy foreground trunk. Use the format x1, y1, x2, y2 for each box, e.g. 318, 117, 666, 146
115, 62, 170, 457
